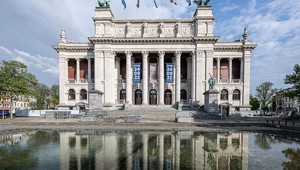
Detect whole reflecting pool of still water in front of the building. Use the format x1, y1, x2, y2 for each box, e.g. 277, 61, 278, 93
0, 130, 300, 170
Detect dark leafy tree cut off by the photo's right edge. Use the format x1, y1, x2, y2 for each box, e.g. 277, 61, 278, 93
284, 64, 300, 98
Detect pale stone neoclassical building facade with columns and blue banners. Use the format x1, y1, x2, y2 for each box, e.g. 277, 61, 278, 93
54, 7, 256, 110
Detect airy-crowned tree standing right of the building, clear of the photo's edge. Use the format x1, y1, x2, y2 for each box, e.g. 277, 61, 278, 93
256, 82, 277, 111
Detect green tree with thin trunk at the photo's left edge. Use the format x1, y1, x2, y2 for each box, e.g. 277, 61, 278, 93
0, 60, 38, 118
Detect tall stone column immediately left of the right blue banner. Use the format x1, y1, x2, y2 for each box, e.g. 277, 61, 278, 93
158, 51, 165, 105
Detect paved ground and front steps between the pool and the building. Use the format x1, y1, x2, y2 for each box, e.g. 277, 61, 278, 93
0, 110, 300, 134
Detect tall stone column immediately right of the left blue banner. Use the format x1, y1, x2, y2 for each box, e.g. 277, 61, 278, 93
142, 51, 149, 105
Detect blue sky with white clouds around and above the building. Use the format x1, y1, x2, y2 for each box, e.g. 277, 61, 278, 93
0, 0, 300, 95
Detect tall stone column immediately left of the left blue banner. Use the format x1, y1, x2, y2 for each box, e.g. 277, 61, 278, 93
125, 51, 132, 104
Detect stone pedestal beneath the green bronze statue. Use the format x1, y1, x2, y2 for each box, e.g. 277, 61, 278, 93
203, 89, 219, 114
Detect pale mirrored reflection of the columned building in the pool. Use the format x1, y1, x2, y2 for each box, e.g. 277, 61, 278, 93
60, 130, 248, 170
